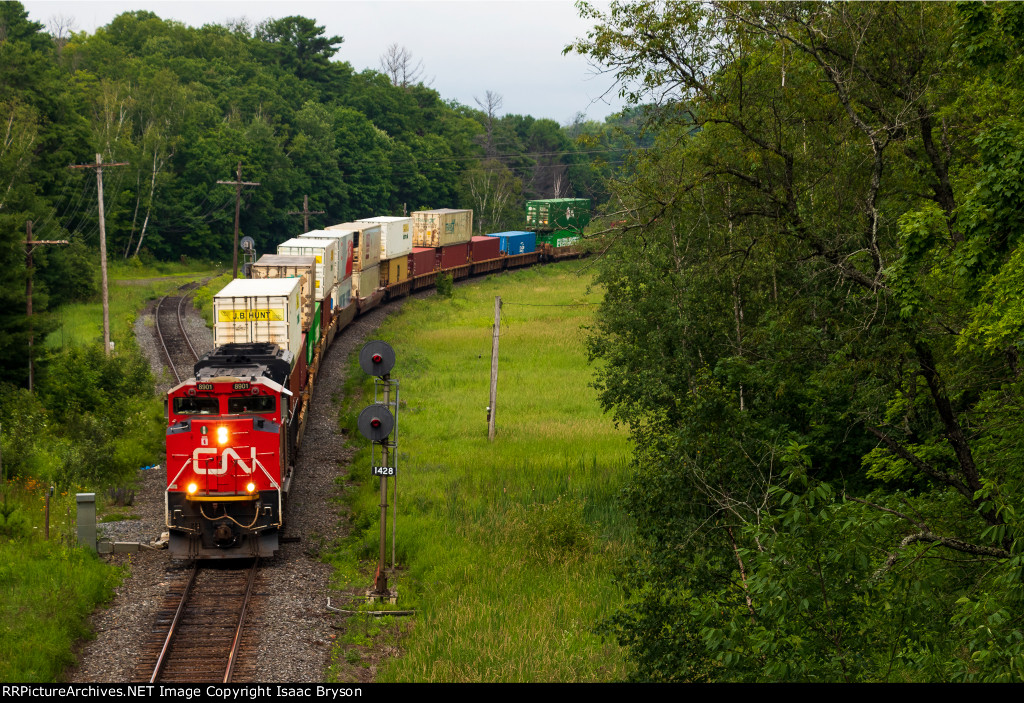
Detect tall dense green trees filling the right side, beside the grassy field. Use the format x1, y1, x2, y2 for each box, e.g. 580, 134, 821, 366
574, 2, 1024, 682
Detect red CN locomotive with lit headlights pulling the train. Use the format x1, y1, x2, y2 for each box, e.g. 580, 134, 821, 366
166, 343, 297, 559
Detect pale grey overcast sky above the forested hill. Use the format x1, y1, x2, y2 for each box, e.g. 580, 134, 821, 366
24, 0, 622, 124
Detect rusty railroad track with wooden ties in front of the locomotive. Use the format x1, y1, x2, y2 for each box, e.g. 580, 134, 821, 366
136, 559, 260, 684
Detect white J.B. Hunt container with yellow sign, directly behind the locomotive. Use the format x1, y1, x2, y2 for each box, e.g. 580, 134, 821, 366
213, 278, 303, 357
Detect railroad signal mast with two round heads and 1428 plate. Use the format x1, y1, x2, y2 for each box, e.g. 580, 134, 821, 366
356, 341, 398, 603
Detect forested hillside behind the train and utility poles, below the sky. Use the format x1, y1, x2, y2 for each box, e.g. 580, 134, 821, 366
0, 2, 636, 386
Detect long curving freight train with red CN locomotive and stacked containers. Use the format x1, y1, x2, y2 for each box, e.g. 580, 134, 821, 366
165, 206, 580, 559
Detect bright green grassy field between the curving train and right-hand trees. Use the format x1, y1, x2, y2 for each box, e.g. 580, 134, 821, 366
332, 262, 631, 682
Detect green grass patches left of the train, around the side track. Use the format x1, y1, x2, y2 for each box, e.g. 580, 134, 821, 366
0, 258, 223, 683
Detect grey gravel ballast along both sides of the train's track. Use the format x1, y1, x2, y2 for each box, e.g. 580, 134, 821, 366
68, 288, 401, 683
